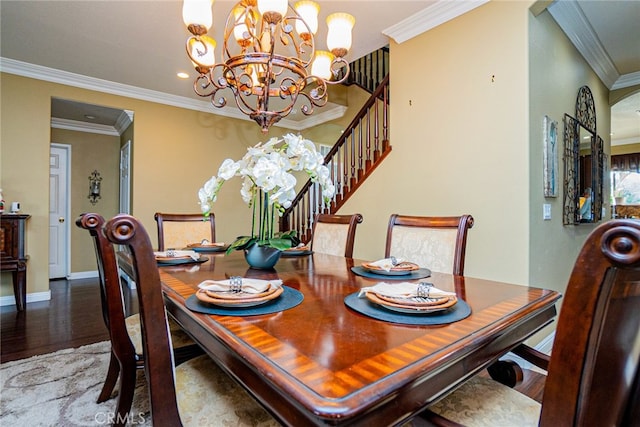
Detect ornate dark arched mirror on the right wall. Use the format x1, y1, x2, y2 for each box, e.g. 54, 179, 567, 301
563, 86, 606, 225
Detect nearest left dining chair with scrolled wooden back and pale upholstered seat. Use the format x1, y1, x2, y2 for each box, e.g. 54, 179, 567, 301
104, 214, 279, 426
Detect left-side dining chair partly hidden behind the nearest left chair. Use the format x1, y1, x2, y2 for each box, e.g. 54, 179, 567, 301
76, 213, 203, 425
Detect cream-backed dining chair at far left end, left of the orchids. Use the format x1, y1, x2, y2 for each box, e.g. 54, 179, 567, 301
154, 212, 216, 251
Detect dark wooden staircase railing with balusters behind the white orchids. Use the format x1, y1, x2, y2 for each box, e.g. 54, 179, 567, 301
280, 48, 391, 242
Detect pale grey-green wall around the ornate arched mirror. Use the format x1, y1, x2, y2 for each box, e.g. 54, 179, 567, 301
528, 8, 611, 302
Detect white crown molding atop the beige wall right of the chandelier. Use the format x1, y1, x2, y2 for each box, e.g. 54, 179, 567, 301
382, 0, 489, 44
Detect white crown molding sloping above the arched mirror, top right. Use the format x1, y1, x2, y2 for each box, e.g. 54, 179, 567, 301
547, 1, 625, 89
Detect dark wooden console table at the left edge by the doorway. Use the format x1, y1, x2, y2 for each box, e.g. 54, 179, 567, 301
0, 214, 31, 311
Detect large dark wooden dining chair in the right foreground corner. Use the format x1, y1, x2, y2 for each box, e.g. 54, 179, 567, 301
422, 219, 640, 427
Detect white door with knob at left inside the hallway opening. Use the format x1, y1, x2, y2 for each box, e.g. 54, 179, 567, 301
49, 144, 71, 279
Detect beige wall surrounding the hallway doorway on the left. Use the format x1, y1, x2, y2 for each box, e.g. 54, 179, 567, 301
0, 73, 272, 296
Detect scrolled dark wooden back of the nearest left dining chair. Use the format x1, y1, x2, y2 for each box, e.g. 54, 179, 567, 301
104, 214, 182, 426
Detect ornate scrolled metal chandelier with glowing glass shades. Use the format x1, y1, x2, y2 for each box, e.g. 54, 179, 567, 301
182, 0, 355, 133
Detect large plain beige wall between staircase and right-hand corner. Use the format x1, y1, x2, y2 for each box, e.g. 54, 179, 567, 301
342, 2, 529, 284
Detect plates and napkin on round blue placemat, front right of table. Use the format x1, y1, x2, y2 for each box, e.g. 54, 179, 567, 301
344, 282, 471, 325
